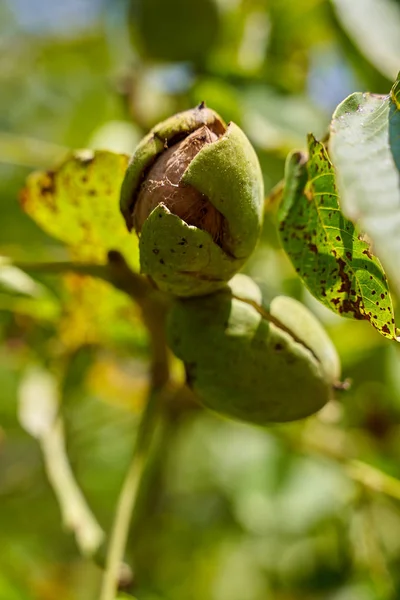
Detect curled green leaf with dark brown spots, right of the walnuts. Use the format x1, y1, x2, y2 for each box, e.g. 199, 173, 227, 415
278, 135, 395, 339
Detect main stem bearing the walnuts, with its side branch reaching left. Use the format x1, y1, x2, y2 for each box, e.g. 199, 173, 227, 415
14, 251, 170, 600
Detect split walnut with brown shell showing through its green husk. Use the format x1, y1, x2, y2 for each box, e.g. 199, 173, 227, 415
121, 104, 263, 296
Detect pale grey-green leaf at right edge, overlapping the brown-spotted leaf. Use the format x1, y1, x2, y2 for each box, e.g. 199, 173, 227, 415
329, 79, 400, 293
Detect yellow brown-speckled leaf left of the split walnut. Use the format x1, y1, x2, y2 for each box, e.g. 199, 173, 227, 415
21, 150, 138, 267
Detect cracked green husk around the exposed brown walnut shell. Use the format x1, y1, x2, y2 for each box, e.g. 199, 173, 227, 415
121, 105, 264, 297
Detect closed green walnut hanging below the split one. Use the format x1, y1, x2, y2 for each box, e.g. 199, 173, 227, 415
168, 275, 340, 425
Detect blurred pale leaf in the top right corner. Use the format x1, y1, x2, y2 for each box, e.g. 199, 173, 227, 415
331, 0, 400, 79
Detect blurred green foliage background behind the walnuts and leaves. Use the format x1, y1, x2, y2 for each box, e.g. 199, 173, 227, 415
0, 0, 400, 600
